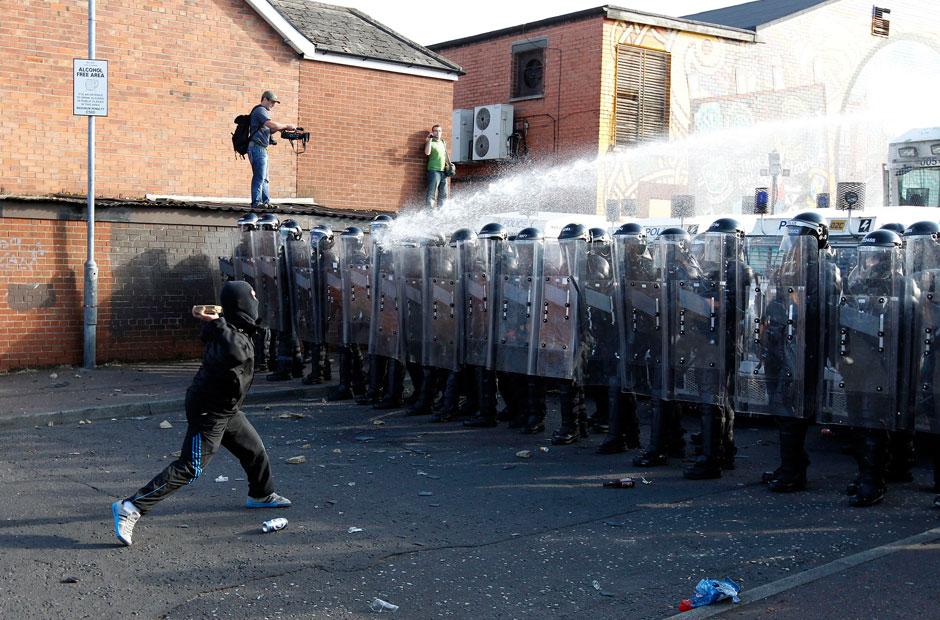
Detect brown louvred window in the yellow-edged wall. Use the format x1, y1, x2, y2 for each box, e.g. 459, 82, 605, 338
615, 45, 670, 146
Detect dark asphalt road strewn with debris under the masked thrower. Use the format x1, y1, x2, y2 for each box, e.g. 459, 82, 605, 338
0, 400, 940, 619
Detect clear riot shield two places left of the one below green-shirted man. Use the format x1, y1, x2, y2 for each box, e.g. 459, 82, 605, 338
369, 243, 402, 359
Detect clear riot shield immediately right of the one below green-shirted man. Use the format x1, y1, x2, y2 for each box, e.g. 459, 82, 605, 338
457, 239, 503, 369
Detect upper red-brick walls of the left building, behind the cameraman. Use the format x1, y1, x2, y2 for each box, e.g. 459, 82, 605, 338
0, 0, 453, 209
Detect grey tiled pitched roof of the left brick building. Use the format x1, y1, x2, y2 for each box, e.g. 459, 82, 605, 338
268, 0, 462, 73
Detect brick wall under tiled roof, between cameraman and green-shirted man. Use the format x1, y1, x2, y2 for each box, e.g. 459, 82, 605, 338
297, 62, 453, 211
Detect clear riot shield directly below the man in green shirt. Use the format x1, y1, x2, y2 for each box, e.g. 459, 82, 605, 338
422, 244, 463, 370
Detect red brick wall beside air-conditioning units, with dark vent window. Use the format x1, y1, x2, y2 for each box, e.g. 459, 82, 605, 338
437, 16, 604, 197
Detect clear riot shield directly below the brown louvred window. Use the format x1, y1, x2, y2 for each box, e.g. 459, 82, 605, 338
613, 235, 668, 399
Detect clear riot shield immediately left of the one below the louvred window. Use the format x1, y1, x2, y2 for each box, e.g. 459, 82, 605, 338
580, 244, 621, 386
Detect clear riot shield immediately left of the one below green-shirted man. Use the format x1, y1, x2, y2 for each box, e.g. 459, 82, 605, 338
394, 242, 427, 364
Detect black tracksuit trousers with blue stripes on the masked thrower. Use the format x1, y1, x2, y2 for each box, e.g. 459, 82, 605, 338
127, 406, 274, 514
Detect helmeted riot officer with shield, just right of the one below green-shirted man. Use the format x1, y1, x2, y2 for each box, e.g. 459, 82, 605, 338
458, 222, 507, 428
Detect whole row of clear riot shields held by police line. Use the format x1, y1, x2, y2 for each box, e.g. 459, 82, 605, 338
220, 213, 940, 433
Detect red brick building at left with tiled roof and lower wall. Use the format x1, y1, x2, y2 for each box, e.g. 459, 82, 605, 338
0, 0, 460, 371
